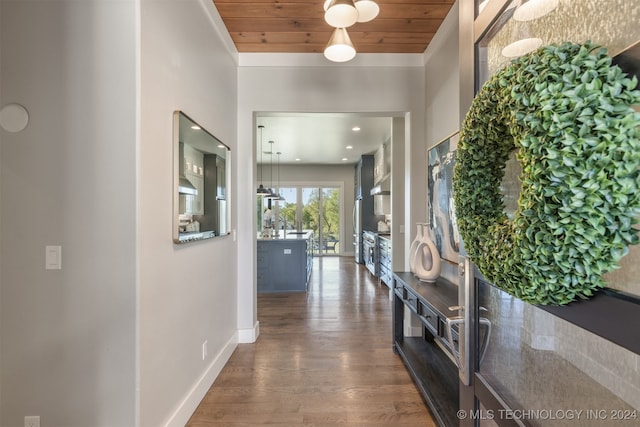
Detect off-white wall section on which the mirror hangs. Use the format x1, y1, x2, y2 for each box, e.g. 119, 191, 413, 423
138, 0, 239, 427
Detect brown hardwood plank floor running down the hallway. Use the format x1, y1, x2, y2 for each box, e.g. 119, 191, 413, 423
187, 257, 435, 427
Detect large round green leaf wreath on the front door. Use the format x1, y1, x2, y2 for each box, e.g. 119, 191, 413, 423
453, 42, 640, 305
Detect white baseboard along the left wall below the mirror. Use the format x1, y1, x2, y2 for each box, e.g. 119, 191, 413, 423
165, 332, 238, 427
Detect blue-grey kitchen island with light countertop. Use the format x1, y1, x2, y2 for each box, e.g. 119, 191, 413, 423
256, 230, 313, 293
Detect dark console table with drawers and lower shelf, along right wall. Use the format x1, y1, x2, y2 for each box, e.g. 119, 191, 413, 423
393, 272, 460, 427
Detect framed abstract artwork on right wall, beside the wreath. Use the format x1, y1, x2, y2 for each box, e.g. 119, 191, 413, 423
427, 132, 462, 264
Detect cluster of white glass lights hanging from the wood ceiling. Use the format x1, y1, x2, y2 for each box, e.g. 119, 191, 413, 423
324, 0, 380, 62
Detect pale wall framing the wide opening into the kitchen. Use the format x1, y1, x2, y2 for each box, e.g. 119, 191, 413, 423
238, 64, 426, 340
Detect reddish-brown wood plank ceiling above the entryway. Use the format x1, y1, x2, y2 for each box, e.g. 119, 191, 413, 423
212, 0, 455, 53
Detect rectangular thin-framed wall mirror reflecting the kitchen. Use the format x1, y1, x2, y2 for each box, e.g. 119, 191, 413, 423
173, 111, 231, 243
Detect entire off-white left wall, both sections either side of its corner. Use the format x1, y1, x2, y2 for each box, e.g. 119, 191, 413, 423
0, 0, 237, 427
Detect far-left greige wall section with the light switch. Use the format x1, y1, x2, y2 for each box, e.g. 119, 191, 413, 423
0, 0, 136, 427
